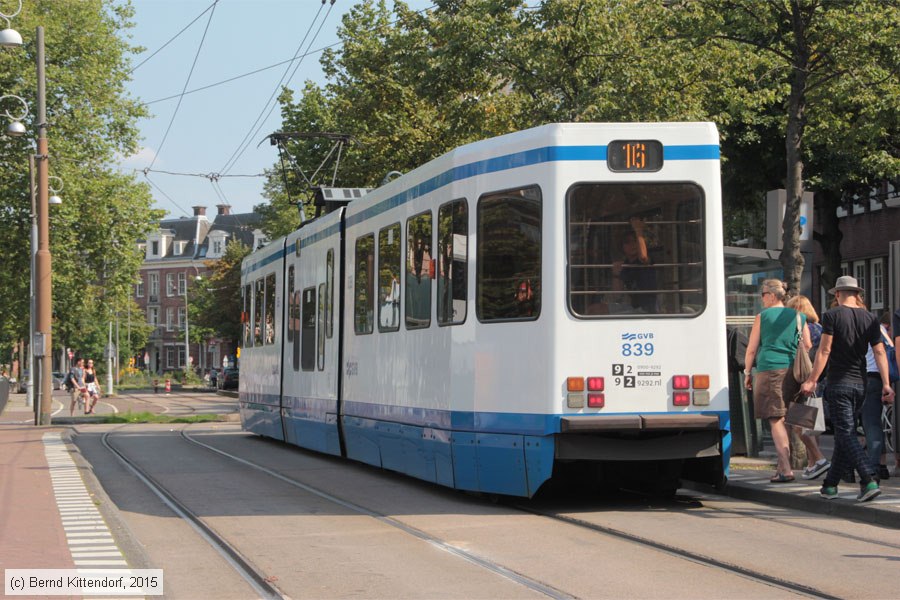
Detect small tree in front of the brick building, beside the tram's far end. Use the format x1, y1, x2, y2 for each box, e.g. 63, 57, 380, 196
188, 242, 250, 345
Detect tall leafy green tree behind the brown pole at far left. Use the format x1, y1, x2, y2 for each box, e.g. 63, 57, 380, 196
0, 0, 160, 364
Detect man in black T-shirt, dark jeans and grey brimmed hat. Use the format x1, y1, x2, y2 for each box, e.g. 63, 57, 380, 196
801, 275, 894, 502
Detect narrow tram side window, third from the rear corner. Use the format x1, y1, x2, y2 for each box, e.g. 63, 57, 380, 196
406, 212, 434, 329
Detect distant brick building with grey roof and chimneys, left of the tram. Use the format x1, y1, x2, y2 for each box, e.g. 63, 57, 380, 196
134, 204, 268, 374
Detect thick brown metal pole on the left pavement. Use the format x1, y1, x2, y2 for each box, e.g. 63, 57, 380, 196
35, 27, 53, 425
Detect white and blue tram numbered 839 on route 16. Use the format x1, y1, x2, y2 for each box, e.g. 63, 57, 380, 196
240, 123, 731, 496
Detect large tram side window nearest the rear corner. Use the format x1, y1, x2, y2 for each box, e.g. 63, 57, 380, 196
475, 187, 541, 322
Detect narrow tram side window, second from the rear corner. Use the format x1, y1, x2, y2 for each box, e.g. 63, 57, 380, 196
436, 200, 469, 325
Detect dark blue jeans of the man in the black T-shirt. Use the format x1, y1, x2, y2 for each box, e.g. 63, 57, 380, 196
824, 384, 875, 487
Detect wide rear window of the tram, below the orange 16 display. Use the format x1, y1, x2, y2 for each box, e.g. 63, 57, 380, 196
567, 183, 706, 317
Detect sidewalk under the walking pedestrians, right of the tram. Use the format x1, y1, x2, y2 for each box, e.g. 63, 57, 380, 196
700, 434, 900, 529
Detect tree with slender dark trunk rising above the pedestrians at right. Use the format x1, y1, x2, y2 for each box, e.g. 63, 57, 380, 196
673, 0, 898, 291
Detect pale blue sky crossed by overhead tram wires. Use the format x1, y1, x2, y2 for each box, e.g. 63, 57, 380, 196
119, 0, 431, 218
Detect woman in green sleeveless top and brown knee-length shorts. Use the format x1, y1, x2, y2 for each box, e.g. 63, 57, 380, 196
744, 279, 812, 483
